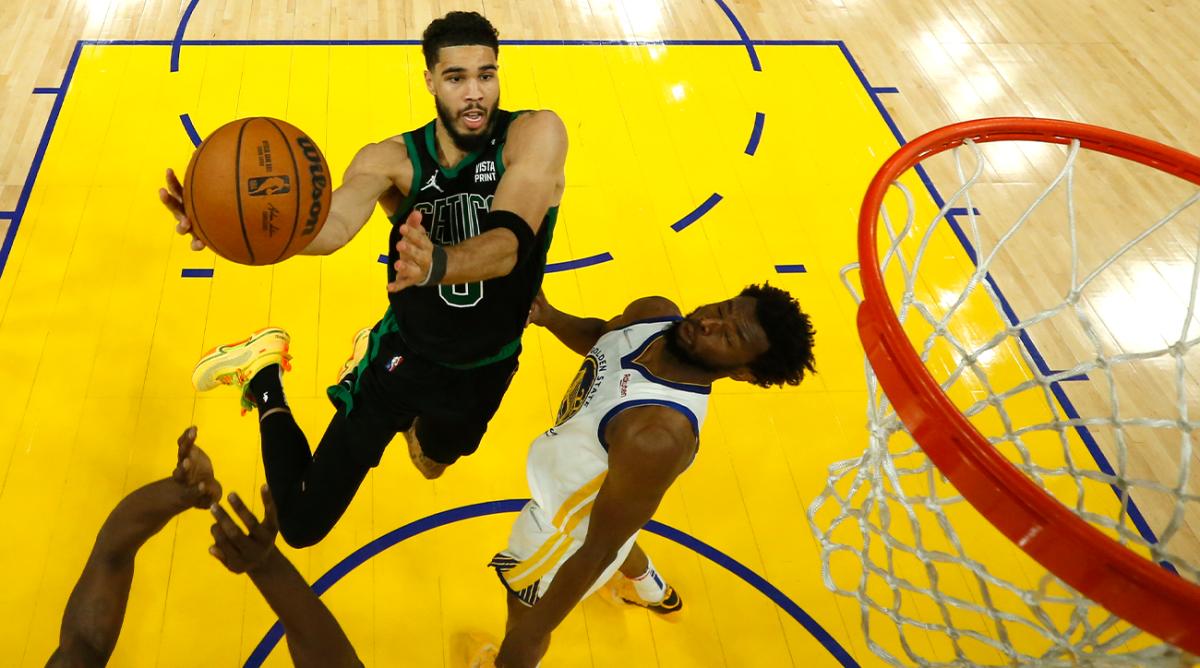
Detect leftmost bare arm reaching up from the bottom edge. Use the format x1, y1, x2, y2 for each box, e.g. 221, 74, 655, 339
47, 427, 221, 667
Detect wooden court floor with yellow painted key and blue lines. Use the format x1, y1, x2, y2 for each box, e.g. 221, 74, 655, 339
0, 0, 1200, 667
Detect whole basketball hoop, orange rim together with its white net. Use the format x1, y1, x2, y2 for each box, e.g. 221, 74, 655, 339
809, 118, 1200, 663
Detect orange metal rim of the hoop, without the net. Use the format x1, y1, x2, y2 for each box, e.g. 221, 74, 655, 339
858, 118, 1200, 655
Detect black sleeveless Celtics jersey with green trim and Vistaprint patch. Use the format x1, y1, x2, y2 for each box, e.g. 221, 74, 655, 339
388, 110, 558, 367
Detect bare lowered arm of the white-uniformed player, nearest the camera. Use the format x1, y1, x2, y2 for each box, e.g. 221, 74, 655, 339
496, 405, 696, 668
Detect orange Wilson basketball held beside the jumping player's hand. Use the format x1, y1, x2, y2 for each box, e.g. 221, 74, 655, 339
184, 118, 332, 265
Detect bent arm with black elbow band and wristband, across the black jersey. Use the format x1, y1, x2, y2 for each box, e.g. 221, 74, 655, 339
388, 110, 568, 293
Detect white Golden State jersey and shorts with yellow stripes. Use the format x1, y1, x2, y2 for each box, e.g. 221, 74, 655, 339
492, 318, 710, 604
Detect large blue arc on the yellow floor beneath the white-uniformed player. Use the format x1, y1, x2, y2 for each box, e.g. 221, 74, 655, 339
244, 499, 858, 668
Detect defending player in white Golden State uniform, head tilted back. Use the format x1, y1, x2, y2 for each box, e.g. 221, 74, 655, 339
491, 284, 815, 668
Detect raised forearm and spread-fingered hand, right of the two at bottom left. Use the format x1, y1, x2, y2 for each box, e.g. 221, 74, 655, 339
209, 485, 362, 668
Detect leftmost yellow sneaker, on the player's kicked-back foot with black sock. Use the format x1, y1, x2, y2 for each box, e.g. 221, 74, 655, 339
192, 327, 292, 415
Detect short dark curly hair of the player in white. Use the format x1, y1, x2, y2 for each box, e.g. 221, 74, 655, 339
739, 283, 817, 387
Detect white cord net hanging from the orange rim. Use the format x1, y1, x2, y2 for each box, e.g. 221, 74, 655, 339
809, 133, 1200, 666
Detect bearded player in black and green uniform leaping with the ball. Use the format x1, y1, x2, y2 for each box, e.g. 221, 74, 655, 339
160, 12, 566, 547
